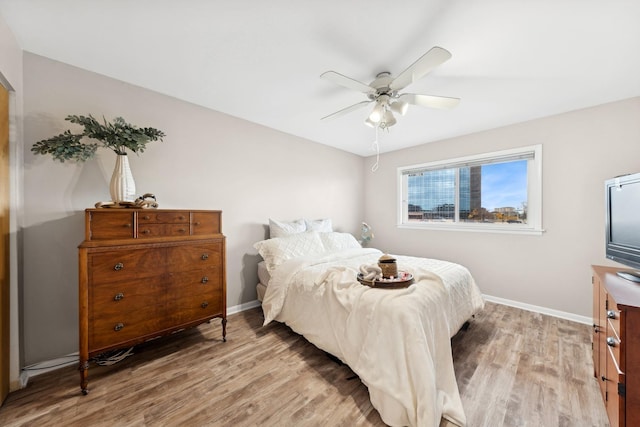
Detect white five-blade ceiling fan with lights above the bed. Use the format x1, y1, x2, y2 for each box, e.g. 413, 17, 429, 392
320, 46, 460, 129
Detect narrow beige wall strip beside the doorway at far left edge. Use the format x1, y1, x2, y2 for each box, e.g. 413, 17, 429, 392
0, 11, 23, 390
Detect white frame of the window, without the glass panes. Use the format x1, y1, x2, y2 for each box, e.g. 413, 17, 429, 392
396, 144, 544, 235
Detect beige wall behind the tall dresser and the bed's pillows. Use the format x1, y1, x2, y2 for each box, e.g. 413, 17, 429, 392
24, 53, 364, 363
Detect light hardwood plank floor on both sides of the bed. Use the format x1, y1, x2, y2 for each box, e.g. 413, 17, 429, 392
0, 303, 608, 427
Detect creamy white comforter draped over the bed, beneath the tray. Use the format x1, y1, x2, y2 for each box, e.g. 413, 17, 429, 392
262, 249, 484, 426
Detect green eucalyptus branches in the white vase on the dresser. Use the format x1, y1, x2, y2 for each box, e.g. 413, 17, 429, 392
31, 115, 165, 163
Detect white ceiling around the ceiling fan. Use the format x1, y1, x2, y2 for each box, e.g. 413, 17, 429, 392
0, 0, 640, 156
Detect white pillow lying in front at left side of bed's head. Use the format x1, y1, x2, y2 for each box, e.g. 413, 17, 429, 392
253, 232, 325, 273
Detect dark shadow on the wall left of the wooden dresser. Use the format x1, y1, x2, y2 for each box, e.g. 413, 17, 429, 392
21, 211, 84, 365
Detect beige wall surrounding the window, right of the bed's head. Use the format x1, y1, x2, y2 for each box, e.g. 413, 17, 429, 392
365, 98, 640, 317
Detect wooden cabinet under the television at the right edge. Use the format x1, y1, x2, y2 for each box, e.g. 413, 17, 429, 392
591, 266, 640, 427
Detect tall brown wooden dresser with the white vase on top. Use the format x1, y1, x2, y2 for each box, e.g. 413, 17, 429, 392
79, 208, 227, 394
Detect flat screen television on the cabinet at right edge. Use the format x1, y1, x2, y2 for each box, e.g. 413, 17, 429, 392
605, 173, 640, 282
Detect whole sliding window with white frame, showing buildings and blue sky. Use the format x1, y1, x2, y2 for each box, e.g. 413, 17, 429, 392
398, 145, 542, 233
